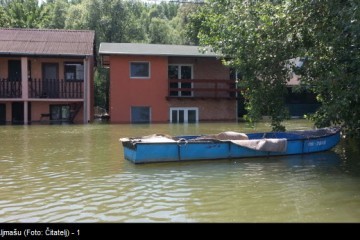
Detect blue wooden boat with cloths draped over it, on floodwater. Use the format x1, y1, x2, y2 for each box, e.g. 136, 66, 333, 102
120, 127, 340, 163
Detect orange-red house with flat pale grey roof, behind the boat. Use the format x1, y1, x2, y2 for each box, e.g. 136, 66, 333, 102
99, 43, 237, 123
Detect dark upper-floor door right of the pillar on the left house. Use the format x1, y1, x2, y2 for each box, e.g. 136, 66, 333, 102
42, 63, 59, 98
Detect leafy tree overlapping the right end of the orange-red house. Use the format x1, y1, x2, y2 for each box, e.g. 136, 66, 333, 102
192, 1, 294, 130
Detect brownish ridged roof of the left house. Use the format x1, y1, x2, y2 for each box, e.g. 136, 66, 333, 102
0, 28, 95, 56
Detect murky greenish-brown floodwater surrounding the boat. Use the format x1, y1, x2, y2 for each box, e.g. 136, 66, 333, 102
0, 120, 360, 222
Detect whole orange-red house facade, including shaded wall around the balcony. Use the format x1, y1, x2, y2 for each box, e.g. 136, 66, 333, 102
109, 55, 237, 123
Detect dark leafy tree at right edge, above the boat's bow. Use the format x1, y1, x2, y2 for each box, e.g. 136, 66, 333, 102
292, 0, 360, 137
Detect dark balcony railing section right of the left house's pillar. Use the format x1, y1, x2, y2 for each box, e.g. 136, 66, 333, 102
29, 79, 83, 98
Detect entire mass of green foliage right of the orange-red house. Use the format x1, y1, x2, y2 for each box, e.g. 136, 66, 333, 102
189, 0, 360, 136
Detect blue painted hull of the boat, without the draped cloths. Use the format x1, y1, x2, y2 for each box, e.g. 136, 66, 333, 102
123, 127, 340, 163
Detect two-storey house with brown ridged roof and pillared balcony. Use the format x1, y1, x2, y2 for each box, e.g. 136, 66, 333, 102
0, 28, 95, 124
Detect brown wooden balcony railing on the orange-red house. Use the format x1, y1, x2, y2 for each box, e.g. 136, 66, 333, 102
167, 79, 240, 99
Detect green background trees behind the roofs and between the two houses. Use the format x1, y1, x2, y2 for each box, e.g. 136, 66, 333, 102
0, 0, 202, 113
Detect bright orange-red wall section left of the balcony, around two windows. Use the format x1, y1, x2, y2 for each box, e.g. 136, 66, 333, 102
109, 56, 169, 123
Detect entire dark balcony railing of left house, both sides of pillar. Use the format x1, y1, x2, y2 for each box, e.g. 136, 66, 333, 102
0, 79, 84, 99
